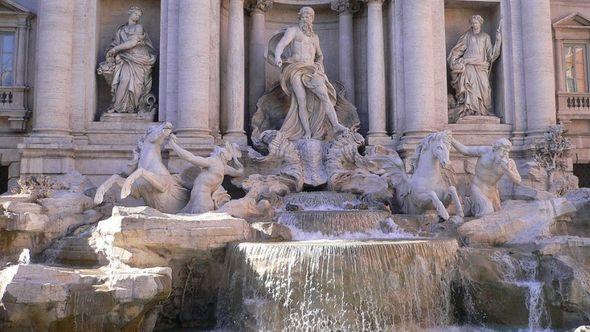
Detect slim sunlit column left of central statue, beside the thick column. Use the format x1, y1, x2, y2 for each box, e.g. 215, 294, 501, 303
223, 0, 247, 145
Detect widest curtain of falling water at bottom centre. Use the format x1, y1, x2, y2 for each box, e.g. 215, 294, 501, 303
218, 240, 457, 331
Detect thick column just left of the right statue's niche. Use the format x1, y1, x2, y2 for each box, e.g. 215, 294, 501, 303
400, 0, 438, 148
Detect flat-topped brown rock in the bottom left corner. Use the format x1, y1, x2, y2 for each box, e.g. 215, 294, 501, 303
0, 265, 171, 331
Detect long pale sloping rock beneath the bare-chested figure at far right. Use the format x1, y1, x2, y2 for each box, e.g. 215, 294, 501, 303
458, 197, 576, 246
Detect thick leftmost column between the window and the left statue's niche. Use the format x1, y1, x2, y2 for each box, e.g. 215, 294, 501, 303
34, 0, 75, 137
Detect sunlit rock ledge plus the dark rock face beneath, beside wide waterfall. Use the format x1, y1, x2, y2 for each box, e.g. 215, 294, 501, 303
89, 207, 252, 328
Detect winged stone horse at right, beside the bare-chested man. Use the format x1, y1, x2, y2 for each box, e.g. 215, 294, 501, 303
387, 131, 463, 220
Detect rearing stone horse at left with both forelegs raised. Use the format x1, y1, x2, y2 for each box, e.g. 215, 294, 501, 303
94, 122, 190, 213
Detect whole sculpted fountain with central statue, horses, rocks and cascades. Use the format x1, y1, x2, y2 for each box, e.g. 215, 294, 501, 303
0, 2, 590, 331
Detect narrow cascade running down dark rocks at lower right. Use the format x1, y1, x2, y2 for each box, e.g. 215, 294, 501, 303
492, 252, 551, 331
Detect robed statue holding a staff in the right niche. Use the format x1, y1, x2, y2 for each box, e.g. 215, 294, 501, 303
447, 15, 502, 122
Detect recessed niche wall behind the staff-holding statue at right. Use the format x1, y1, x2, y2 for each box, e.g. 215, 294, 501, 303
445, 0, 510, 123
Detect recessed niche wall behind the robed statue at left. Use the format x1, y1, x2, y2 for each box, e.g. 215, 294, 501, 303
94, 0, 161, 121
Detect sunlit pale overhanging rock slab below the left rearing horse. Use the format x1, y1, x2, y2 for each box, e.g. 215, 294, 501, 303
91, 206, 250, 267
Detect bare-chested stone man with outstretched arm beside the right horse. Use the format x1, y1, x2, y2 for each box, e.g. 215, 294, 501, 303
451, 138, 521, 217
